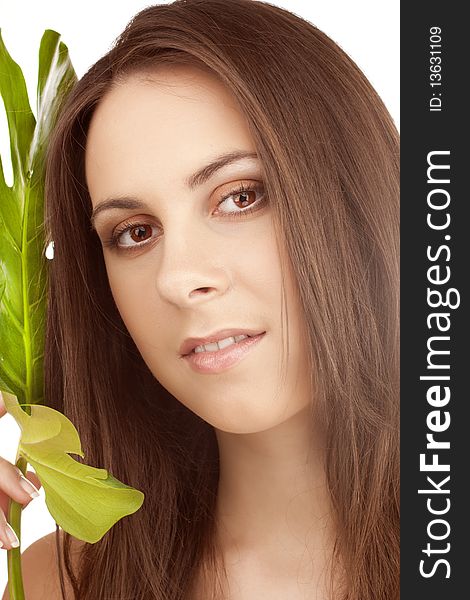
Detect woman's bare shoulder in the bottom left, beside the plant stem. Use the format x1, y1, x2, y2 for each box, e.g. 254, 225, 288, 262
2, 530, 83, 600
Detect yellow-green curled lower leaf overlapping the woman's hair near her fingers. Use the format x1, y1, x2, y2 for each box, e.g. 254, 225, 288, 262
3, 392, 144, 543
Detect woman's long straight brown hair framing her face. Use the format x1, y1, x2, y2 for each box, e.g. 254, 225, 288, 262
45, 0, 399, 600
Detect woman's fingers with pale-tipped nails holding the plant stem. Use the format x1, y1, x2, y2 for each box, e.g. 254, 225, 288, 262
0, 392, 41, 550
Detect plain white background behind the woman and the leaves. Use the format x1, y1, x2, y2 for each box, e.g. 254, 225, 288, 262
0, 0, 400, 593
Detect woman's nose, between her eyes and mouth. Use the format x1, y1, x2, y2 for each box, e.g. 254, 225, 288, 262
156, 226, 231, 307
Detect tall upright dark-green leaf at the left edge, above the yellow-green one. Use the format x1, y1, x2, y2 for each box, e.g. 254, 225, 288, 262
0, 30, 76, 404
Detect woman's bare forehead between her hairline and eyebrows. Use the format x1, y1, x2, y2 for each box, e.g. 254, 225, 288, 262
85, 66, 256, 206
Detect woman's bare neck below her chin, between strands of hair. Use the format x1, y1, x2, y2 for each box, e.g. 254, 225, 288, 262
216, 408, 334, 578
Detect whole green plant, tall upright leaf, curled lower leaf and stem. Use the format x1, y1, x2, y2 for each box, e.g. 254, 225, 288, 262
0, 30, 144, 552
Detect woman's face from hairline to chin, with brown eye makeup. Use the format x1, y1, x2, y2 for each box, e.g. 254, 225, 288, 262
86, 65, 310, 433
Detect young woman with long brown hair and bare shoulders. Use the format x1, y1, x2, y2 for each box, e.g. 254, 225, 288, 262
1, 0, 399, 600
